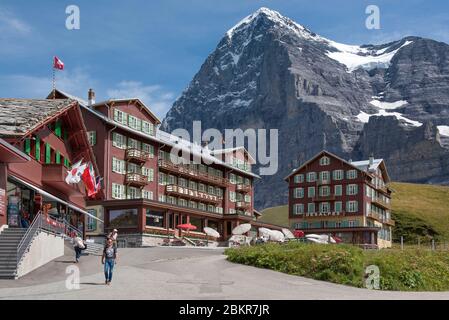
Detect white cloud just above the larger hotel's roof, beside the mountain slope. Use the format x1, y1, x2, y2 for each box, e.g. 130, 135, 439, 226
107, 81, 175, 119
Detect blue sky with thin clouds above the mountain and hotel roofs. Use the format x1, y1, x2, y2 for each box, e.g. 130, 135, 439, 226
0, 0, 449, 118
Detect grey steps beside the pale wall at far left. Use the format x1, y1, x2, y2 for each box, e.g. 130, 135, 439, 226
0, 228, 27, 279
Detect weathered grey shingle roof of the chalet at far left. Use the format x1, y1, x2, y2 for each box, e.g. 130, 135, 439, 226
0, 98, 76, 136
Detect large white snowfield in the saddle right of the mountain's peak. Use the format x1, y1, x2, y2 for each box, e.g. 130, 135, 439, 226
326, 40, 413, 73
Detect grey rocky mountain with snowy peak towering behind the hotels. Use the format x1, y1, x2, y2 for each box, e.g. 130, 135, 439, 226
162, 8, 449, 209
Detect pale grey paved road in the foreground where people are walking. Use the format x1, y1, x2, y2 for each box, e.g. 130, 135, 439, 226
0, 247, 449, 300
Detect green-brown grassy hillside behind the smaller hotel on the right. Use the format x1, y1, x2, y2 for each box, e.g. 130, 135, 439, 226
261, 183, 449, 242
